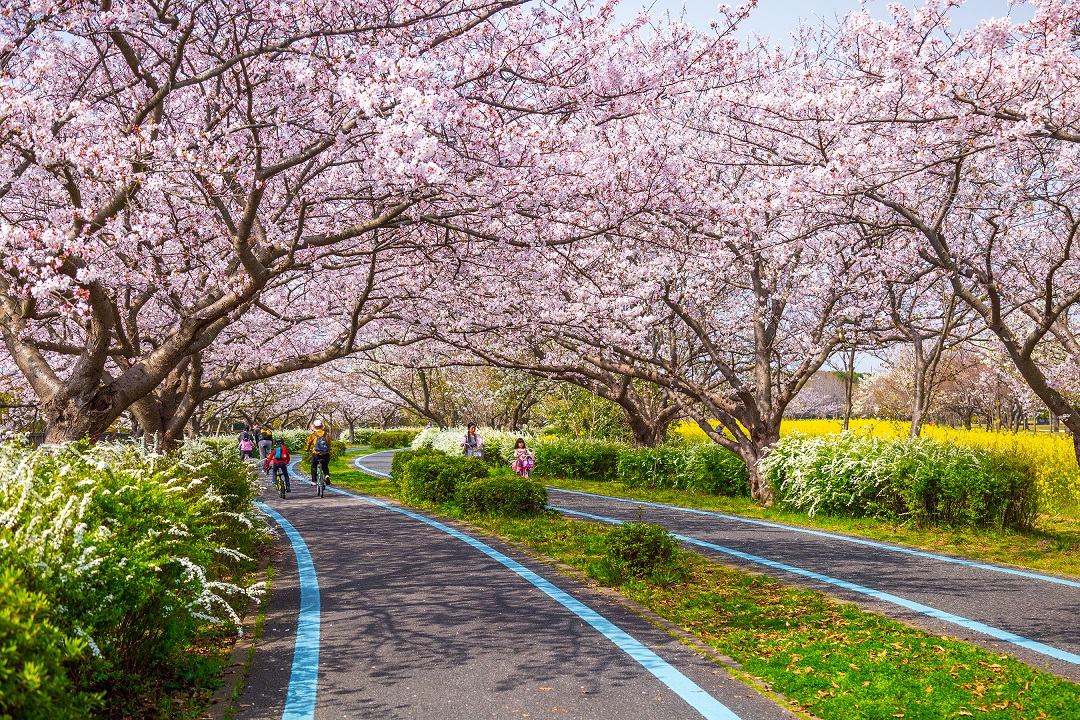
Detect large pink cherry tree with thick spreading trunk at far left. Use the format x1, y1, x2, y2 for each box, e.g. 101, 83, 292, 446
0, 0, 686, 440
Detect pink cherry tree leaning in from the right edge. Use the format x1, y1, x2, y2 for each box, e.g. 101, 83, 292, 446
756, 0, 1080, 462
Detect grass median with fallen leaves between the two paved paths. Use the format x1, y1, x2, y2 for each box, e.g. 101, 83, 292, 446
332, 459, 1080, 720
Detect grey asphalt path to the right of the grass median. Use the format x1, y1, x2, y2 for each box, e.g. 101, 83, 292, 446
549, 488, 1080, 680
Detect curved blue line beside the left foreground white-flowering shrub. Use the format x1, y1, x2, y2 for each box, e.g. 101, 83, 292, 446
255, 502, 320, 720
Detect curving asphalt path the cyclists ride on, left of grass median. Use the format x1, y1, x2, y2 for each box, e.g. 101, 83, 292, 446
239, 453, 793, 720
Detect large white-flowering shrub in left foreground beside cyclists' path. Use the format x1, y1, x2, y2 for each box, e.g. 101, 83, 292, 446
0, 443, 266, 717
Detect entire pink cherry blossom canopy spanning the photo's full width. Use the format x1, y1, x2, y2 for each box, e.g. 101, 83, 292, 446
0, 0, 1080, 474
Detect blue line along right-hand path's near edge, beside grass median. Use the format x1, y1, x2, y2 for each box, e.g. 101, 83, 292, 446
548, 505, 1080, 665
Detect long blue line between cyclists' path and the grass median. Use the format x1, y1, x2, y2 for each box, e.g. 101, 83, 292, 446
327, 483, 740, 720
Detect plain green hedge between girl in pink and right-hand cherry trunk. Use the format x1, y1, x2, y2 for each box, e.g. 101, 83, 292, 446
534, 438, 750, 495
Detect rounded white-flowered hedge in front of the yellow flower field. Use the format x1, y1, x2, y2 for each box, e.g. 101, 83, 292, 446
761, 433, 1039, 529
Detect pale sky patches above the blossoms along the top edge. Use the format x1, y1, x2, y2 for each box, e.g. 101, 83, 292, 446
619, 0, 1031, 42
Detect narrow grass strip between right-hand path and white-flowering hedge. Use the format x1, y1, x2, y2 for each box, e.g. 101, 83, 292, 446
543, 478, 1080, 578
